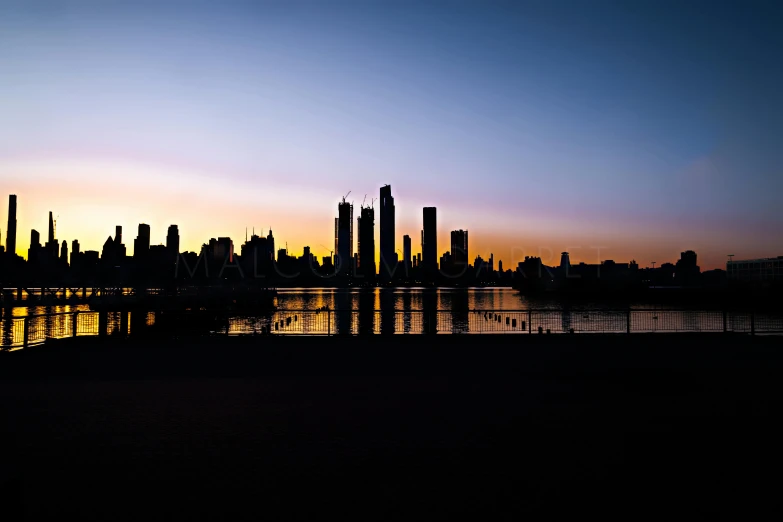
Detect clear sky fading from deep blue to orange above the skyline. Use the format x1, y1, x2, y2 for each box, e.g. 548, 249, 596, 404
0, 0, 783, 268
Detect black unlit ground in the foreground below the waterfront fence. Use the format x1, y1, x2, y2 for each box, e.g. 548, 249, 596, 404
0, 334, 783, 521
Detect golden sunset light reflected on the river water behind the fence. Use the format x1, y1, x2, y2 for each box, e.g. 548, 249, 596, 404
0, 288, 783, 346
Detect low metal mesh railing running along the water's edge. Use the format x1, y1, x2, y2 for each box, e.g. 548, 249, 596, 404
0, 309, 783, 349
